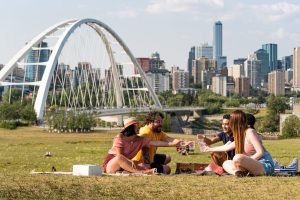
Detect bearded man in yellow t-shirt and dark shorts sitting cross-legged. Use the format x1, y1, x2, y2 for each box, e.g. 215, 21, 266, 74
133, 111, 181, 174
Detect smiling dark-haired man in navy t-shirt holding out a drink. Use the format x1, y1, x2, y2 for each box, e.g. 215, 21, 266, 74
197, 114, 235, 167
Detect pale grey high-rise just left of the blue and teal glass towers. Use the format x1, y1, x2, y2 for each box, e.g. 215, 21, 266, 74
244, 54, 261, 88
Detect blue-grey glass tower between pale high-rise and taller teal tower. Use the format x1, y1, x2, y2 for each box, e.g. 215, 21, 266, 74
254, 49, 270, 82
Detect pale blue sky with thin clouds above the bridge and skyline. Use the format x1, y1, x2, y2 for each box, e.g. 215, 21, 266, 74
0, 0, 300, 70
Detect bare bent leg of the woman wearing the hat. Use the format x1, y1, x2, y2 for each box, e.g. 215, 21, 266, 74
106, 155, 154, 174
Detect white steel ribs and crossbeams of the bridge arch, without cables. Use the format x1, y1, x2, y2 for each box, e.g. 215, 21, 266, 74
0, 19, 162, 119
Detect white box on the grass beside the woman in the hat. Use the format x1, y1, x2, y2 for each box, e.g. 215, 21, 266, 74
73, 164, 102, 176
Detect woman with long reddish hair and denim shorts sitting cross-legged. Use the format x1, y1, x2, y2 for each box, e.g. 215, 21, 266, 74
205, 110, 274, 177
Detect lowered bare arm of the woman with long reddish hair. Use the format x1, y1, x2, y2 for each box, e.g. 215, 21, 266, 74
246, 129, 264, 160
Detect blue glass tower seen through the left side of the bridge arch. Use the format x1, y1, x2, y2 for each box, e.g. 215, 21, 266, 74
25, 42, 50, 82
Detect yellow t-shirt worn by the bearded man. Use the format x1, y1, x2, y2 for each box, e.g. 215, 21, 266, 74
132, 125, 168, 163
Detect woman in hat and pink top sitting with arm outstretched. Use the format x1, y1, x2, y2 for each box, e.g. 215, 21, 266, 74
103, 117, 177, 174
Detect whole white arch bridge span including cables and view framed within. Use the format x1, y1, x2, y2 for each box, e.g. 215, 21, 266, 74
0, 19, 162, 119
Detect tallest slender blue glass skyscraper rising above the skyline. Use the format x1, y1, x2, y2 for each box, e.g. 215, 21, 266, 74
213, 21, 227, 70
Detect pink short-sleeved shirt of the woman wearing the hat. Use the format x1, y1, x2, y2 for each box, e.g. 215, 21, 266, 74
108, 135, 150, 159
